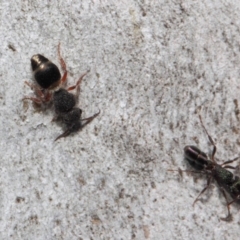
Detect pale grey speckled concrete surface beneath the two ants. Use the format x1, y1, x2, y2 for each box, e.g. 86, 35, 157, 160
0, 0, 240, 240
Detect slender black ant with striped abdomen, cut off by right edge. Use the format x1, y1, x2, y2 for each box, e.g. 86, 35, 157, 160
170, 115, 240, 221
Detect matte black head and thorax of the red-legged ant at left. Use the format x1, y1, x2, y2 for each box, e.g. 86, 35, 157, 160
53, 77, 100, 141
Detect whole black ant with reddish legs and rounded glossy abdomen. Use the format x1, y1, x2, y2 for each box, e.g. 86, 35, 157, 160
24, 44, 100, 141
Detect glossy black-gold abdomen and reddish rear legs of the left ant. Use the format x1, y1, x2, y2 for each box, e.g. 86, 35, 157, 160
23, 44, 67, 104
